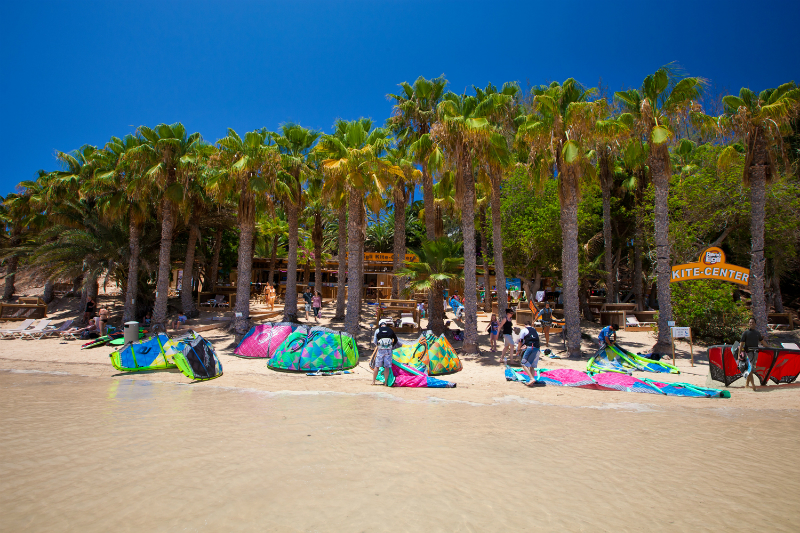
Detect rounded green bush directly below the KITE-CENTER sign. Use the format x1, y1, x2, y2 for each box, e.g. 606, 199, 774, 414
672, 280, 750, 344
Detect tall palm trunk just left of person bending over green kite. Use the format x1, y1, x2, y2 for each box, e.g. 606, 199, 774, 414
559, 164, 581, 357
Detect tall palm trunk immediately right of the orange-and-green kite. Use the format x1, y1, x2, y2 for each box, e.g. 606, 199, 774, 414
461, 149, 478, 354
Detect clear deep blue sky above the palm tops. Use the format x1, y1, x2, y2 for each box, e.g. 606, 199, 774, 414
0, 0, 800, 195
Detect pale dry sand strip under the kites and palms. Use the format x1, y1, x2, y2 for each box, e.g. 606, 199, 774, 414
0, 290, 800, 410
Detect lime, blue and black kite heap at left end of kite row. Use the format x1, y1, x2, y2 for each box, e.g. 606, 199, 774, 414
109, 331, 222, 381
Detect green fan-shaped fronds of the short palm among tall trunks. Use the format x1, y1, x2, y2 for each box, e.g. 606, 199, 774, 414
399, 237, 464, 308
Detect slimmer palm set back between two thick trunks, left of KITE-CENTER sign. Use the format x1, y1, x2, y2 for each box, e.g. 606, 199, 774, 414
594, 115, 630, 303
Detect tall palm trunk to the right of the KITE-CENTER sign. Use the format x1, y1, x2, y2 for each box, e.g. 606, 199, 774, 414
748, 130, 769, 336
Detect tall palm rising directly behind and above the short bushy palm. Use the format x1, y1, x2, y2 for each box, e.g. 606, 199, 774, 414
387, 75, 447, 239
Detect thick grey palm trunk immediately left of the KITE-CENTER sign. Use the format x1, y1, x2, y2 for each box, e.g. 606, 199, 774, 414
648, 145, 676, 351
